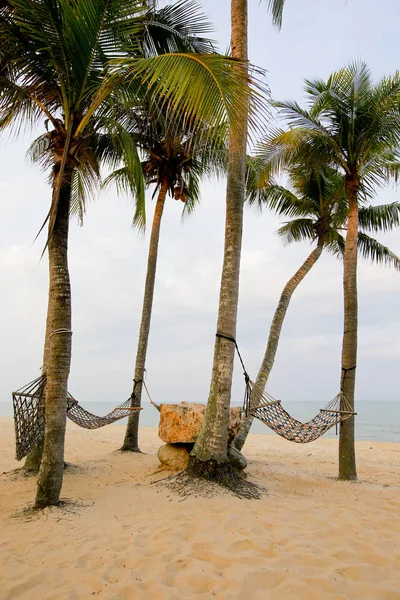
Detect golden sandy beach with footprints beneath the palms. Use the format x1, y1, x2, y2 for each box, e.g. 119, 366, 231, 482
0, 417, 400, 600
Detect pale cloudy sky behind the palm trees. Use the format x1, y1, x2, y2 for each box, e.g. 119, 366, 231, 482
0, 0, 400, 405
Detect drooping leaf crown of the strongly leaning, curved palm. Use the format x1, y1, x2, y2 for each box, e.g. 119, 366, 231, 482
247, 157, 400, 270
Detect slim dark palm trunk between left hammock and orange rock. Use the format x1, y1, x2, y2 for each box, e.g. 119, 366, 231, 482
121, 180, 168, 452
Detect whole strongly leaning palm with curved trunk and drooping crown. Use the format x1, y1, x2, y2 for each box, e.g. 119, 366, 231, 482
233, 161, 400, 450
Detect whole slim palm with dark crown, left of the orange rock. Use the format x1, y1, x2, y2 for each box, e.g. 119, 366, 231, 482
105, 111, 227, 452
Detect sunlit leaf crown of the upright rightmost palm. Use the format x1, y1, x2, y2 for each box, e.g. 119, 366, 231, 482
258, 62, 400, 195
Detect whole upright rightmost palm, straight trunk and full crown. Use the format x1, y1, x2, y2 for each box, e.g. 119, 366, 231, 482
255, 63, 400, 479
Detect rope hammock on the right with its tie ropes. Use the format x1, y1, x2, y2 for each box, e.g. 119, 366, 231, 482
216, 333, 357, 444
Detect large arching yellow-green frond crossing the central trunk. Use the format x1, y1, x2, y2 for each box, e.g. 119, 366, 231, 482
102, 53, 265, 148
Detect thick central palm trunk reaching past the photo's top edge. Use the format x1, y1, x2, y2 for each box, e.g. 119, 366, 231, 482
187, 0, 247, 479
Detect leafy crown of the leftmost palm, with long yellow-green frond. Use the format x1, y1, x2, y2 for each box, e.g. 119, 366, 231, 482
0, 0, 260, 140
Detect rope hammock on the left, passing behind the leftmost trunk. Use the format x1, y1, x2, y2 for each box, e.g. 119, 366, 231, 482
12, 375, 141, 460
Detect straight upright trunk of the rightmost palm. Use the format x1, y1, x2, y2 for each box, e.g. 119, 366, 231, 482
339, 177, 359, 480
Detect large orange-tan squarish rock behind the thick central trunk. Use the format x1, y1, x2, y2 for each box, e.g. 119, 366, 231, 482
158, 402, 241, 444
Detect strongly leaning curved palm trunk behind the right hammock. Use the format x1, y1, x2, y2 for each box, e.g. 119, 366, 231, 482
232, 240, 323, 450
